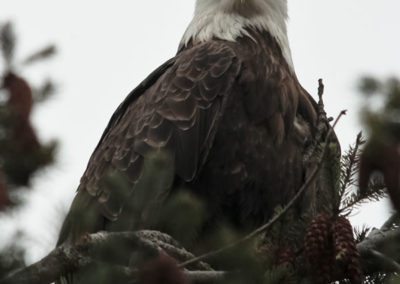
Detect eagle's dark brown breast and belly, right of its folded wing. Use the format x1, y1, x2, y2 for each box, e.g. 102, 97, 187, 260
186, 30, 316, 228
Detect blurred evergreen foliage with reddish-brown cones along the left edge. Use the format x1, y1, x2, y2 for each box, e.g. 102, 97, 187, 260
0, 22, 57, 278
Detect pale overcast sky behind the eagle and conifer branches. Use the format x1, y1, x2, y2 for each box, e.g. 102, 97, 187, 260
0, 0, 400, 261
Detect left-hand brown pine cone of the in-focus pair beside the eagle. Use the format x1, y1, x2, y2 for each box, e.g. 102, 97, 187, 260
304, 214, 334, 283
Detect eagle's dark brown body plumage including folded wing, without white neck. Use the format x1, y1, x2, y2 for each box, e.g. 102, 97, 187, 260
73, 28, 315, 230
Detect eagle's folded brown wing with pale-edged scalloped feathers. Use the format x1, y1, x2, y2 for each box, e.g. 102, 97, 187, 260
74, 41, 240, 223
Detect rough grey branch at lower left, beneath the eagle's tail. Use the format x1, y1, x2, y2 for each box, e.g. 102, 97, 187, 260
0, 231, 198, 284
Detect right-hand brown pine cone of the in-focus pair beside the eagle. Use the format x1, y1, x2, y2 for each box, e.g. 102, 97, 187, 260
332, 217, 362, 284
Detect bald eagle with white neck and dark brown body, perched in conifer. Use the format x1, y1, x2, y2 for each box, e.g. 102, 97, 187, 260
59, 0, 317, 260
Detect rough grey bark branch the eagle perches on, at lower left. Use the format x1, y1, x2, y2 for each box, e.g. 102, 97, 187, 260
0, 230, 212, 284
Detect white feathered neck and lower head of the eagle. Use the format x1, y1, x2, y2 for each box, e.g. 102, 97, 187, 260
181, 0, 293, 66
